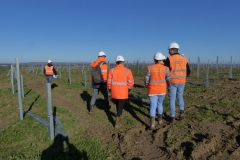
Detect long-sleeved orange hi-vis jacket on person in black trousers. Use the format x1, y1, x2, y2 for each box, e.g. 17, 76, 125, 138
107, 64, 134, 99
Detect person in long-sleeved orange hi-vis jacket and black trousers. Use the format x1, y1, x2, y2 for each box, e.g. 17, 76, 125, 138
107, 55, 134, 128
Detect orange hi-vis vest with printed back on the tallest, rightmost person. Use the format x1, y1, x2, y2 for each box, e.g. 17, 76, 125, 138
168, 54, 188, 84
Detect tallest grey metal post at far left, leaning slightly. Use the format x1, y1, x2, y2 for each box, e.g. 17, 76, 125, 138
16, 58, 23, 120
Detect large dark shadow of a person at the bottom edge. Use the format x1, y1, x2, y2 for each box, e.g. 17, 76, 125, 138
41, 134, 88, 160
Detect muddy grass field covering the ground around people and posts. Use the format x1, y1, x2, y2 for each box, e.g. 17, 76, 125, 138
0, 64, 240, 160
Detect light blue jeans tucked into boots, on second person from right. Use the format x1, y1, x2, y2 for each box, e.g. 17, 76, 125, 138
149, 95, 165, 117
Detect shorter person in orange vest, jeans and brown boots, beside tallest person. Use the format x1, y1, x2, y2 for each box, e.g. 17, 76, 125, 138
144, 52, 171, 129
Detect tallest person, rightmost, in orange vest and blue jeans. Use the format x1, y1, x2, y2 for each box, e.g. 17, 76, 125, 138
165, 42, 190, 122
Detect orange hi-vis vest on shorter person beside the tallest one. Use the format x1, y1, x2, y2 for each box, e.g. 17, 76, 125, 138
148, 63, 169, 96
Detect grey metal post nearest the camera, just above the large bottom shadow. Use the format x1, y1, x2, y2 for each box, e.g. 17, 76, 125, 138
46, 83, 54, 140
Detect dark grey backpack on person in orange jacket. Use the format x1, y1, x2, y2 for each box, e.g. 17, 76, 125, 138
92, 62, 106, 84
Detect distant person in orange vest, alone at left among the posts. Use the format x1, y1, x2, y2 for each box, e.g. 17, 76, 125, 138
43, 60, 57, 83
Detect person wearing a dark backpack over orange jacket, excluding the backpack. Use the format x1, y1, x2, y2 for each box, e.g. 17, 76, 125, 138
89, 51, 111, 114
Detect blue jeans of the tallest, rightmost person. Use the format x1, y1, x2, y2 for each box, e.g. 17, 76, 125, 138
168, 84, 185, 117
